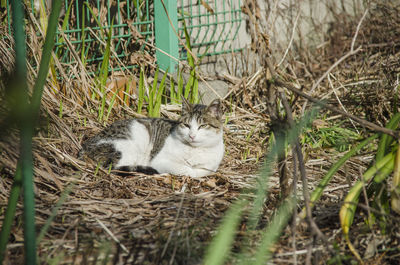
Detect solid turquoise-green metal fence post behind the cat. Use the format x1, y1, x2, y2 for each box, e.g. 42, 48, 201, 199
154, 0, 179, 73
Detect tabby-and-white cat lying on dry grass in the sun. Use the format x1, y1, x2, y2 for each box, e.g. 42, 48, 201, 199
80, 99, 224, 178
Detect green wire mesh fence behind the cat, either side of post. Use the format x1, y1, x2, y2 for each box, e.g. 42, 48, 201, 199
0, 0, 242, 70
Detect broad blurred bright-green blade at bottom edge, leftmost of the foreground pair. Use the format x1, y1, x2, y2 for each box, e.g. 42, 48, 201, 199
203, 199, 247, 265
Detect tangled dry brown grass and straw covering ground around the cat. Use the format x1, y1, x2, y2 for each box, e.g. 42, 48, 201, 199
0, 2, 400, 264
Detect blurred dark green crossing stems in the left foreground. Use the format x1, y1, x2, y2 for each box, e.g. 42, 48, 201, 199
0, 0, 62, 264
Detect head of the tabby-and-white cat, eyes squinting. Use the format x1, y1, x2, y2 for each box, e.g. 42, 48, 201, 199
177, 99, 223, 147
